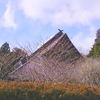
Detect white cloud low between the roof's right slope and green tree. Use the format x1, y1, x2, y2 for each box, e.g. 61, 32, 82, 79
72, 26, 96, 54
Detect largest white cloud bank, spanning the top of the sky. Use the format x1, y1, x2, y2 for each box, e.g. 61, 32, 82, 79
20, 0, 100, 26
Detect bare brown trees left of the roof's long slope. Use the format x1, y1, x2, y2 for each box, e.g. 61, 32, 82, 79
0, 42, 26, 80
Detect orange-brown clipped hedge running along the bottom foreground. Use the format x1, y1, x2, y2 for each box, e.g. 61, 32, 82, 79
0, 82, 100, 100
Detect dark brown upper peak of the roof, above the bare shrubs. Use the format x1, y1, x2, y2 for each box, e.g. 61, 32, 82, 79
32, 31, 82, 63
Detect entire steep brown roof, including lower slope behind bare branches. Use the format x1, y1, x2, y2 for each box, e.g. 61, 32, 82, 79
9, 31, 81, 81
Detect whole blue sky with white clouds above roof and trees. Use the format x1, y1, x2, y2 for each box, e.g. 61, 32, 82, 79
0, 0, 100, 54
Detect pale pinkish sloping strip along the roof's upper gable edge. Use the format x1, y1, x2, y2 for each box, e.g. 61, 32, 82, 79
40, 33, 66, 55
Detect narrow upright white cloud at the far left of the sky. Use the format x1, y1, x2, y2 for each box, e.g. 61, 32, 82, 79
0, 1, 17, 29
